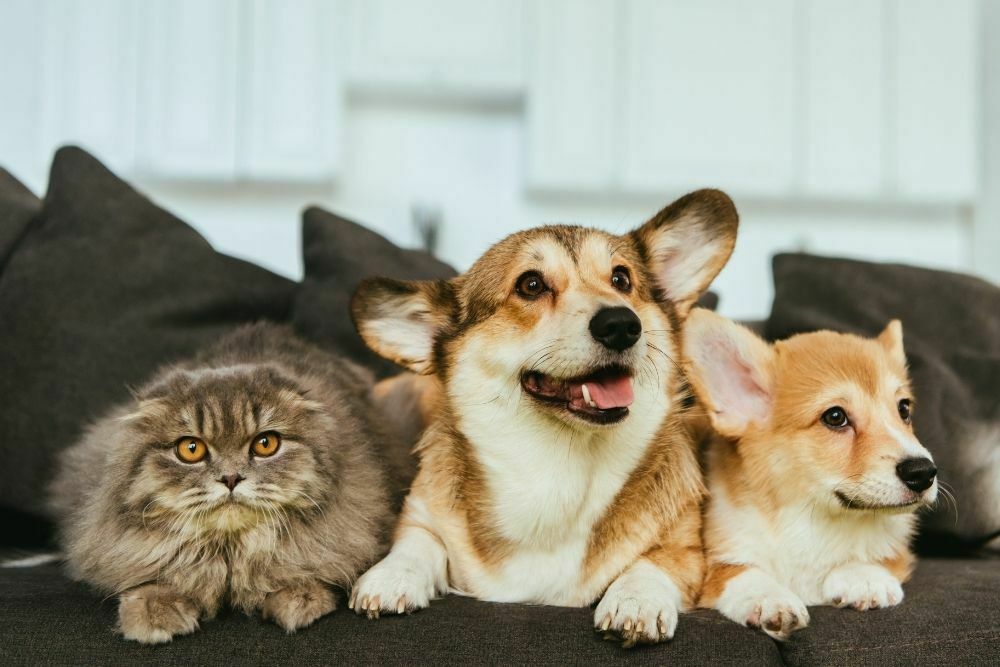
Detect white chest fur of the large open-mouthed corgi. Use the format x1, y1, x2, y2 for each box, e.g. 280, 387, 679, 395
446, 376, 667, 606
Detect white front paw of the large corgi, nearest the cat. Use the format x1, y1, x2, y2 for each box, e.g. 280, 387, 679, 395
348, 554, 435, 618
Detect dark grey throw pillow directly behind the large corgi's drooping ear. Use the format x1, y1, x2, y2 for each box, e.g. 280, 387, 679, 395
293, 207, 456, 377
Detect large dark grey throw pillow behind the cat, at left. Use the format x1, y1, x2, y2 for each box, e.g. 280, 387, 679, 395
0, 148, 296, 543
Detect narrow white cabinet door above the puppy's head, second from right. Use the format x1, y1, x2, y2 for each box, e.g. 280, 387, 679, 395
800, 0, 889, 198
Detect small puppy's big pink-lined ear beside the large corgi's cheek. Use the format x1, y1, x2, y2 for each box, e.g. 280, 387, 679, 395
684, 308, 774, 438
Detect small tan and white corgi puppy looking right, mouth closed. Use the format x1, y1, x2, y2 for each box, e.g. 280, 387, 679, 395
684, 309, 938, 639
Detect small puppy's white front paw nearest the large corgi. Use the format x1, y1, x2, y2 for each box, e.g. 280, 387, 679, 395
715, 570, 809, 641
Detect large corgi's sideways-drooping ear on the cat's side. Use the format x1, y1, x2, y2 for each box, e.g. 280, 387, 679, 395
351, 278, 456, 374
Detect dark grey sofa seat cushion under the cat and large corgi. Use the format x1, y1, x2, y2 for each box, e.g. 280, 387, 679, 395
0, 565, 780, 666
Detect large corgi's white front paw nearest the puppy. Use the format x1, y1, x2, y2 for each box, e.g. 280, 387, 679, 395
594, 562, 681, 648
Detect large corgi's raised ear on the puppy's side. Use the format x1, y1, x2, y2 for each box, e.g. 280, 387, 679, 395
632, 190, 739, 317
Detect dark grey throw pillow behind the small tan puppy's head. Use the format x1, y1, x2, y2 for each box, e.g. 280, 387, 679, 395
767, 254, 1000, 550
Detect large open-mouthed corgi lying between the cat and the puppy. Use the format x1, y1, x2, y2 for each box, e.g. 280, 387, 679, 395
350, 190, 737, 645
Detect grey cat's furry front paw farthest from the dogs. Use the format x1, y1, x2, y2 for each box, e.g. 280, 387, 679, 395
118, 584, 199, 644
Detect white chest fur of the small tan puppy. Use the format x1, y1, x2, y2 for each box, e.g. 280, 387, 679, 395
709, 488, 913, 605
